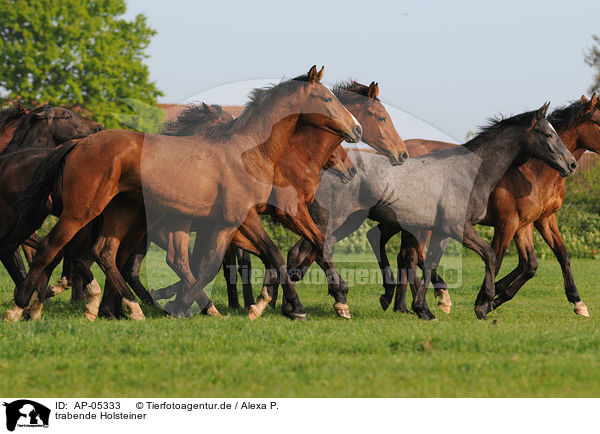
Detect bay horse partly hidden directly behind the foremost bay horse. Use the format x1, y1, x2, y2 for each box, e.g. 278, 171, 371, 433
153, 81, 396, 319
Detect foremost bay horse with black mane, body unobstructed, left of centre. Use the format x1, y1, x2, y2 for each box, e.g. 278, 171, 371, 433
8, 66, 361, 320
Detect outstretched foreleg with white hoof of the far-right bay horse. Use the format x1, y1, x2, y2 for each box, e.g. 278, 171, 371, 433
534, 214, 590, 316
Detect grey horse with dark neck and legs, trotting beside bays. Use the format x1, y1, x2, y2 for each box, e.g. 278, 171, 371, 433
288, 104, 577, 320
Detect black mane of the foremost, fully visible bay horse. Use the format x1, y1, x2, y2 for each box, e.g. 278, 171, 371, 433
203, 74, 310, 140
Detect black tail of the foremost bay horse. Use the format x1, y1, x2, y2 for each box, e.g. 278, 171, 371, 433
16, 141, 77, 227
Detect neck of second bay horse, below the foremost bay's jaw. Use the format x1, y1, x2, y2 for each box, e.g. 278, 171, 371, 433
290, 127, 342, 173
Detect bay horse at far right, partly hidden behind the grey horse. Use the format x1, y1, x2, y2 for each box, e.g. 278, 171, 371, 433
373, 94, 600, 316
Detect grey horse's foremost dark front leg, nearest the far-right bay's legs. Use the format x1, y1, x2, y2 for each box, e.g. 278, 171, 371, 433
462, 223, 496, 319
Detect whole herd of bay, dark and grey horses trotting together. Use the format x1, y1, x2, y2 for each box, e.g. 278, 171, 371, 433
0, 66, 600, 321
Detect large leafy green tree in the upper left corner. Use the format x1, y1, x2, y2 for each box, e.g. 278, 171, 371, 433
0, 0, 162, 128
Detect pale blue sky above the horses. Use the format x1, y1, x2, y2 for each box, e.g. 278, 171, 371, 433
127, 0, 600, 141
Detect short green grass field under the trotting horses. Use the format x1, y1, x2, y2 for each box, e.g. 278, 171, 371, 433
0, 252, 600, 397
